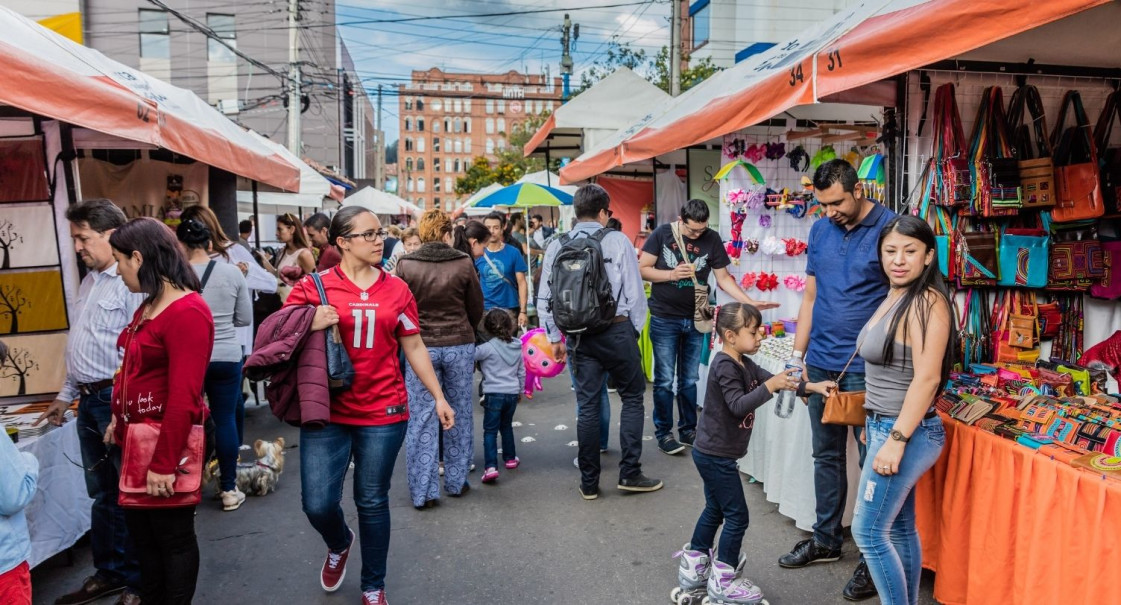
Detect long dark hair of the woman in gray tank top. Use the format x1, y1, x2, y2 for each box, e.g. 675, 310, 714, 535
876, 215, 957, 382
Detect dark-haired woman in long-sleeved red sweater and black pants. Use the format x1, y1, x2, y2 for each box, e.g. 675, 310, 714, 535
105, 218, 214, 604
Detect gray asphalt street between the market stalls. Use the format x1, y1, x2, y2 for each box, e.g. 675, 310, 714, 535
33, 376, 935, 605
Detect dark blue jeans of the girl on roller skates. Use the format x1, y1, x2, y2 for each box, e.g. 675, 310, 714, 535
689, 449, 748, 567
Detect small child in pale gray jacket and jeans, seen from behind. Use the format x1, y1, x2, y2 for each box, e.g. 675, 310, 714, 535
475, 308, 526, 483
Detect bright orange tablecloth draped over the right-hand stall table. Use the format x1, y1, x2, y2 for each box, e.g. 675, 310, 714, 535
916, 417, 1121, 605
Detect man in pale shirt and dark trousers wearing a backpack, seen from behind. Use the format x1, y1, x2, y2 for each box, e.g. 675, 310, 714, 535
537, 185, 663, 500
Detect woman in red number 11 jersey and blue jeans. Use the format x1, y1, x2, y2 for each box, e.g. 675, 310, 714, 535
286, 206, 455, 605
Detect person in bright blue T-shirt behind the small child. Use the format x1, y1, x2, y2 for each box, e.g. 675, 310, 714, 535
475, 212, 527, 326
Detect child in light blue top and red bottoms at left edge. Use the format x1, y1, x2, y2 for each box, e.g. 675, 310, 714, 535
0, 343, 39, 605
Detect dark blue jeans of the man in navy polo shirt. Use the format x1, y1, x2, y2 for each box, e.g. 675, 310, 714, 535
806, 365, 865, 549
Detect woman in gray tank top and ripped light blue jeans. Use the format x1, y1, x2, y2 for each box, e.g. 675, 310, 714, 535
852, 216, 954, 605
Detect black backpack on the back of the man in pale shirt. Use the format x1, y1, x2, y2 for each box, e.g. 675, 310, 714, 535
549, 229, 617, 334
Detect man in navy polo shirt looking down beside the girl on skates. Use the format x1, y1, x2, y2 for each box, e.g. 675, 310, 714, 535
779, 159, 895, 601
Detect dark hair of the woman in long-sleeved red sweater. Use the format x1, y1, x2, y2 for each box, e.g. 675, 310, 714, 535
109, 217, 202, 304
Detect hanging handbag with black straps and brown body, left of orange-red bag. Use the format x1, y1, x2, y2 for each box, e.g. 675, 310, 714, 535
1008, 85, 1055, 208
